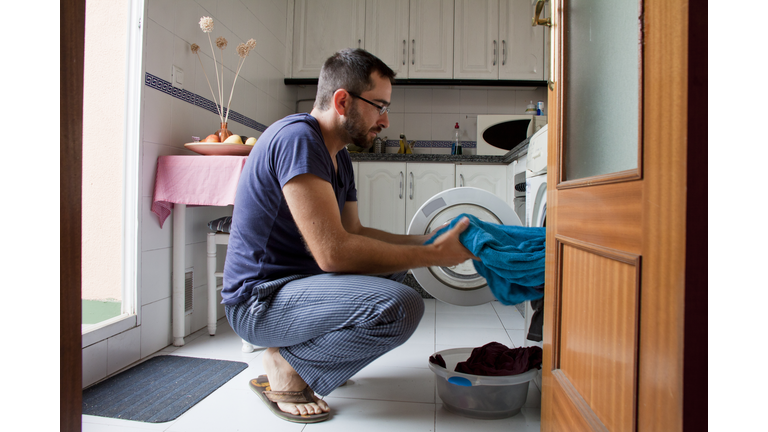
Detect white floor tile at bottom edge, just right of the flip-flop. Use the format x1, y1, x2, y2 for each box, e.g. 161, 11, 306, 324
308, 396, 435, 432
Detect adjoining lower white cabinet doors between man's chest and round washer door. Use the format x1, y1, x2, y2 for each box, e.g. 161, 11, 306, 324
357, 162, 455, 234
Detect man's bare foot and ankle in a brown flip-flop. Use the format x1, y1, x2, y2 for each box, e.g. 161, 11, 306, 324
262, 348, 330, 415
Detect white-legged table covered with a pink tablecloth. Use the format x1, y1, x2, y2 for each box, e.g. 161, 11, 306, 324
152, 156, 248, 346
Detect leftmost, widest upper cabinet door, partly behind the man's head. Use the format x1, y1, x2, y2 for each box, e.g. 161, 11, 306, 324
293, 0, 365, 78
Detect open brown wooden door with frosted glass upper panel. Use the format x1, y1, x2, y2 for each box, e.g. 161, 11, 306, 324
541, 0, 706, 432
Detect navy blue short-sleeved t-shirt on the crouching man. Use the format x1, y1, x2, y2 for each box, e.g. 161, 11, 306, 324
221, 114, 357, 305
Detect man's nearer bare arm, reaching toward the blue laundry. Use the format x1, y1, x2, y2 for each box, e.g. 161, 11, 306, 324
283, 174, 473, 274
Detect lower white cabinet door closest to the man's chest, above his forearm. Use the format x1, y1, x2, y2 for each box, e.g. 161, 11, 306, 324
357, 162, 407, 234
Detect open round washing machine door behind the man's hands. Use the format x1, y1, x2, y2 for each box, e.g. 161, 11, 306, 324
408, 187, 522, 306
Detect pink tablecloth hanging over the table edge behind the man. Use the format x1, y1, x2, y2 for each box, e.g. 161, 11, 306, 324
152, 156, 248, 228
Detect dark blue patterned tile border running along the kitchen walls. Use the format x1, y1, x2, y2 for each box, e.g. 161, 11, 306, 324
144, 73, 477, 148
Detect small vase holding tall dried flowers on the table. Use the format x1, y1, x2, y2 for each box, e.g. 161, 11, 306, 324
191, 17, 256, 142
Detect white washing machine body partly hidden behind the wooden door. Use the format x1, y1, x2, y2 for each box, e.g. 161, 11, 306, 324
523, 126, 548, 347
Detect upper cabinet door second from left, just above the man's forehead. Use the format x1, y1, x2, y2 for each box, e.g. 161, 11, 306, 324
365, 0, 410, 78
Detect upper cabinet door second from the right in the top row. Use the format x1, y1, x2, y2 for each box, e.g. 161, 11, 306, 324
453, 0, 501, 80
